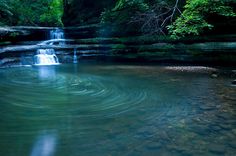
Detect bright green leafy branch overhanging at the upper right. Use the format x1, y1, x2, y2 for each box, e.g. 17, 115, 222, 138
168, 0, 236, 39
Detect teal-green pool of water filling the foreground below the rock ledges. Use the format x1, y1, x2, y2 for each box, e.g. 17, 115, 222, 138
0, 64, 236, 156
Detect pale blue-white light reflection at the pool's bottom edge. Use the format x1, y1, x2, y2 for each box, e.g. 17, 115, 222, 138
30, 132, 57, 156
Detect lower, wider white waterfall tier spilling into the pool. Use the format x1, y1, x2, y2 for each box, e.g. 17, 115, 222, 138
34, 49, 59, 65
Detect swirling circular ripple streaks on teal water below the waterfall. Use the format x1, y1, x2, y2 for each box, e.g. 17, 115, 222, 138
0, 68, 147, 115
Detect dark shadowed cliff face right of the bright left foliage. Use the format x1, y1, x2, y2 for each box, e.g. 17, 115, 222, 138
63, 0, 116, 26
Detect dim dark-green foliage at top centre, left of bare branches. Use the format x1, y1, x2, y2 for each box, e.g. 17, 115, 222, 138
101, 0, 149, 24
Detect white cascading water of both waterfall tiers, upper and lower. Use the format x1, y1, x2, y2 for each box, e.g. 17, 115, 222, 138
34, 29, 65, 65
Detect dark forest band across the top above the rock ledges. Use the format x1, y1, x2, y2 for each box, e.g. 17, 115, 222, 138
0, 0, 236, 39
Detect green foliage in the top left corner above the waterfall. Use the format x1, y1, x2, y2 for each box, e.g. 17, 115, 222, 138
0, 0, 63, 26
